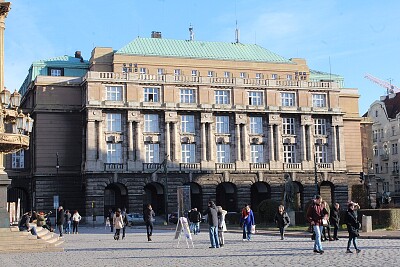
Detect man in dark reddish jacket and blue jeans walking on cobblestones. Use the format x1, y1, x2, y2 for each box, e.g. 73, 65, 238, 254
307, 195, 325, 254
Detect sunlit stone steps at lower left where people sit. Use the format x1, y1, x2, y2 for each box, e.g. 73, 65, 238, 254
0, 227, 64, 253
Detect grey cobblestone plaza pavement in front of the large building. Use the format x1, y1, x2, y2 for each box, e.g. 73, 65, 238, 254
0, 227, 400, 267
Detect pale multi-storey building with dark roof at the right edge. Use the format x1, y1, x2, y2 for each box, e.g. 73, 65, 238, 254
367, 93, 400, 206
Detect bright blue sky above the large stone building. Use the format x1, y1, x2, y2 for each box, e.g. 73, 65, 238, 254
5, 0, 400, 115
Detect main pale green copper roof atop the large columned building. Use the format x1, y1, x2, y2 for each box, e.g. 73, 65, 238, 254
116, 37, 293, 64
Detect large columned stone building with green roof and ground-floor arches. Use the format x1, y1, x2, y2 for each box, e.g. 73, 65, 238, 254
5, 35, 362, 221
